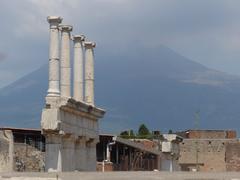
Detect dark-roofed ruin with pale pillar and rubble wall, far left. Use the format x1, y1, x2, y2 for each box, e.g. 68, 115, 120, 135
0, 127, 45, 172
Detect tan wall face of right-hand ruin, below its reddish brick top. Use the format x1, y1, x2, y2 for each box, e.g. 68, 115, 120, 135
179, 139, 234, 171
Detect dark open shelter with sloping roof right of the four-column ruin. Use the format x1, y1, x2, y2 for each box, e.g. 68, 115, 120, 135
97, 134, 162, 171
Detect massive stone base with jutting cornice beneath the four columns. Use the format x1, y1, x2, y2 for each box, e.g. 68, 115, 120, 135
41, 97, 105, 172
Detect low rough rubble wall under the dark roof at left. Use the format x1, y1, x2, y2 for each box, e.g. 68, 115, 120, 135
14, 143, 44, 172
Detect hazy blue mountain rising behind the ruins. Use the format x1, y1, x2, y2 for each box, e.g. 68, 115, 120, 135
0, 45, 240, 132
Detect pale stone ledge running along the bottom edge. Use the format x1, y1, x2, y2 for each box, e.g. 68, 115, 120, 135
0, 171, 240, 180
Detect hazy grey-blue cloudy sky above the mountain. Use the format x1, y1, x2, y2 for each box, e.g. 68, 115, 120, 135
0, 0, 240, 87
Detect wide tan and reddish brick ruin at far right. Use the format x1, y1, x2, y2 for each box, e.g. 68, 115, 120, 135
179, 130, 240, 172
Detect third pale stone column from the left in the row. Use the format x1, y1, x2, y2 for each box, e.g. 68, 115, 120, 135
73, 35, 85, 101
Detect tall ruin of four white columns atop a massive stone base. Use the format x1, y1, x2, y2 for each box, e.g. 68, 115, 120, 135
41, 16, 105, 171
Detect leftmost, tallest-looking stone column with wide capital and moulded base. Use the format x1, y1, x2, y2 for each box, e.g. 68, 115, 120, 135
47, 16, 62, 97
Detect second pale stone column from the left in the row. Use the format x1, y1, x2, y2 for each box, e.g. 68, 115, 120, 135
60, 25, 72, 98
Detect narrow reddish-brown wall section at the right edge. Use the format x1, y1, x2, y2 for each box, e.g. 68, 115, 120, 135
226, 141, 240, 171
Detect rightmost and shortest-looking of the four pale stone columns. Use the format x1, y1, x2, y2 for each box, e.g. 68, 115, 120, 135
84, 42, 96, 105
